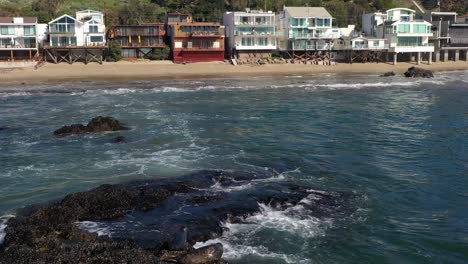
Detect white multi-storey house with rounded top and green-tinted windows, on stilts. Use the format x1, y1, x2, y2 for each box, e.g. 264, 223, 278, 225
362, 8, 434, 64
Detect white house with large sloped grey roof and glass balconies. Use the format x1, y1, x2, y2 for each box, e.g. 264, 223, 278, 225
276, 6, 340, 52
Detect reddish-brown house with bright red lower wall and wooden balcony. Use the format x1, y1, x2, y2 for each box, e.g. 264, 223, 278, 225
166, 13, 224, 63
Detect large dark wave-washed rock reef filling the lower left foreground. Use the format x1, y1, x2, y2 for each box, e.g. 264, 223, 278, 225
0, 171, 355, 264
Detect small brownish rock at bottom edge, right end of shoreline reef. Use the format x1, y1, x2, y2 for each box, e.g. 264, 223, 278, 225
179, 243, 223, 264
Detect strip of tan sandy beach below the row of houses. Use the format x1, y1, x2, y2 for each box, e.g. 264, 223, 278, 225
0, 61, 468, 84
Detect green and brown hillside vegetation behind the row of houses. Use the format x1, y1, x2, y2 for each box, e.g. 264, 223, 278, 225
0, 0, 460, 26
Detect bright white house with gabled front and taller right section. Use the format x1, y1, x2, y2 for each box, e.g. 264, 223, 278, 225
47, 10, 106, 47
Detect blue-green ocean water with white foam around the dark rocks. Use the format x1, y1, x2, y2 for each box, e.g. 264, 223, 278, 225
0, 72, 468, 263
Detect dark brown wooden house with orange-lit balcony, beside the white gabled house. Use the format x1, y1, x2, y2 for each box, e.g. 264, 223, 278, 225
107, 23, 166, 58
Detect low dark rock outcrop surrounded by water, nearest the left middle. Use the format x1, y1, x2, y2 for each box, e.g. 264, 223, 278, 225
54, 116, 128, 136
